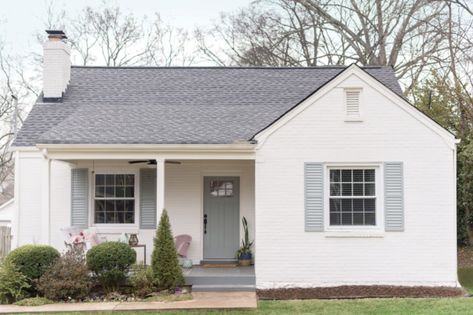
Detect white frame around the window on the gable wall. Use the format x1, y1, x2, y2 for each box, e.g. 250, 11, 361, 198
324, 163, 384, 232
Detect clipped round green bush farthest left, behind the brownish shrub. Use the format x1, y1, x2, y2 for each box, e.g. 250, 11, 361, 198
5, 245, 60, 283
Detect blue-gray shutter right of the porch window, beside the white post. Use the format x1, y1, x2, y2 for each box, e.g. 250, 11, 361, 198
140, 168, 156, 229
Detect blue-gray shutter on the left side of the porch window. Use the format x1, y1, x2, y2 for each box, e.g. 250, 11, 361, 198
71, 168, 89, 228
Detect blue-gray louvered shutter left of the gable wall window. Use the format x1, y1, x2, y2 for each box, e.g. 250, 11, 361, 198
304, 163, 324, 232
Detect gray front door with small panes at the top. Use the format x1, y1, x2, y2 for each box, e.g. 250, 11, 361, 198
204, 176, 240, 260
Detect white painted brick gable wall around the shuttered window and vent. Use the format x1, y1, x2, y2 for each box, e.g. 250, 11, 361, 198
255, 73, 457, 288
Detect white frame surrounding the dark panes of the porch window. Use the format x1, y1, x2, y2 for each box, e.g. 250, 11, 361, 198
89, 168, 140, 232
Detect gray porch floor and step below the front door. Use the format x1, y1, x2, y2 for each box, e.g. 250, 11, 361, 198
183, 266, 256, 292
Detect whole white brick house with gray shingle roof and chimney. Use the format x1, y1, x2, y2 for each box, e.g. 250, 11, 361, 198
13, 32, 458, 289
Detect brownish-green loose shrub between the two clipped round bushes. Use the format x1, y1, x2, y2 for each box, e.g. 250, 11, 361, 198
38, 251, 92, 301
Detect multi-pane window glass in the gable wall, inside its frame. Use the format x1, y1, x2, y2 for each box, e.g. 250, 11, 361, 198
329, 168, 376, 226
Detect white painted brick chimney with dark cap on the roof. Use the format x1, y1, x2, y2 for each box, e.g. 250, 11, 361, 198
43, 30, 71, 102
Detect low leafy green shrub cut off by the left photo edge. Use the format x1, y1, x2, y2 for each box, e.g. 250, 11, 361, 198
0, 262, 30, 304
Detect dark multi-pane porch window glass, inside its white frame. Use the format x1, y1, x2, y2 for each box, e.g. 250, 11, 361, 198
94, 174, 135, 224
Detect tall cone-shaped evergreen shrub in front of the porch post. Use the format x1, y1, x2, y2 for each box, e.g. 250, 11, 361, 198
151, 209, 184, 290
